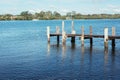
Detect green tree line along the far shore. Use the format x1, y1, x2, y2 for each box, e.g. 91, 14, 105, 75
0, 11, 120, 20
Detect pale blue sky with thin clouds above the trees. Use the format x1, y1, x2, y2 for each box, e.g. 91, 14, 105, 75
0, 0, 120, 14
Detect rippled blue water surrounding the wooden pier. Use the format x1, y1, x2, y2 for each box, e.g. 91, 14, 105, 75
0, 19, 120, 80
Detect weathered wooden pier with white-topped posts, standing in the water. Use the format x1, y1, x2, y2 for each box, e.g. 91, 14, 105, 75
47, 21, 120, 48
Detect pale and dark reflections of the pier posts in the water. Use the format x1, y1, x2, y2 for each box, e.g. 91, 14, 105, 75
47, 43, 115, 65
